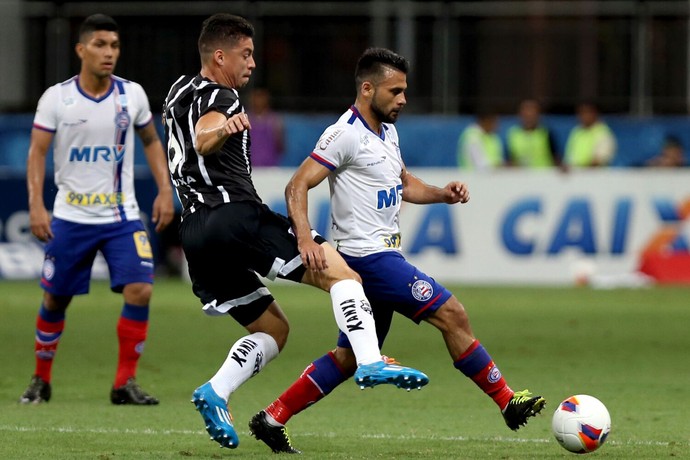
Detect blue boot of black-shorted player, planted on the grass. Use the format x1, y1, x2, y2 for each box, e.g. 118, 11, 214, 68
192, 382, 240, 449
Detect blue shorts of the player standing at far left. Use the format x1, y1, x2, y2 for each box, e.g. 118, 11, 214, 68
41, 218, 153, 296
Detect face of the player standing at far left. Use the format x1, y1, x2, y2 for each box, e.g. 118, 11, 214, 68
77, 30, 120, 78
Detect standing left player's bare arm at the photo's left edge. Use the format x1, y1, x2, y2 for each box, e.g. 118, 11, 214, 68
26, 128, 53, 241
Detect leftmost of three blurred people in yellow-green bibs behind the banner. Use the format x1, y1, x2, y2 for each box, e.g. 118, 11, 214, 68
457, 112, 505, 171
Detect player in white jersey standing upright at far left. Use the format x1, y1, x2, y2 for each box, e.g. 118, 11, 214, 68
20, 14, 173, 405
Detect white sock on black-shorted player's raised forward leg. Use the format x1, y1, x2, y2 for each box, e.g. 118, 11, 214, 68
331, 280, 381, 365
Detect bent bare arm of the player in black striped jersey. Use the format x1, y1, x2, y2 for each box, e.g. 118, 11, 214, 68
194, 110, 251, 155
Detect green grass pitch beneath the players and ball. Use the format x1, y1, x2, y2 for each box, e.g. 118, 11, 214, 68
0, 280, 690, 460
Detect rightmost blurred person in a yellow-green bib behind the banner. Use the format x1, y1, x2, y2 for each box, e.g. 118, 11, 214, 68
563, 102, 616, 167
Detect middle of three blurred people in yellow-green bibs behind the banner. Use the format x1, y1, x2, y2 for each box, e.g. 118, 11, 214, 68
507, 99, 560, 168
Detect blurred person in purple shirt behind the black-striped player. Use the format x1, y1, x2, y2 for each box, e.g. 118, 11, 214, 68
247, 88, 285, 167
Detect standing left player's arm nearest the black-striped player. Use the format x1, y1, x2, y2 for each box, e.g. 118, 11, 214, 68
137, 122, 175, 232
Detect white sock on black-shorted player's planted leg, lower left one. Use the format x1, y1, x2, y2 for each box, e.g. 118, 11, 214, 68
209, 332, 278, 401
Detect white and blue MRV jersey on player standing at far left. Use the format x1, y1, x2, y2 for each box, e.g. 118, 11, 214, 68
34, 76, 152, 224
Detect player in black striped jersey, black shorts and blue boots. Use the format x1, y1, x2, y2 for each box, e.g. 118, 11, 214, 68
164, 14, 428, 448
